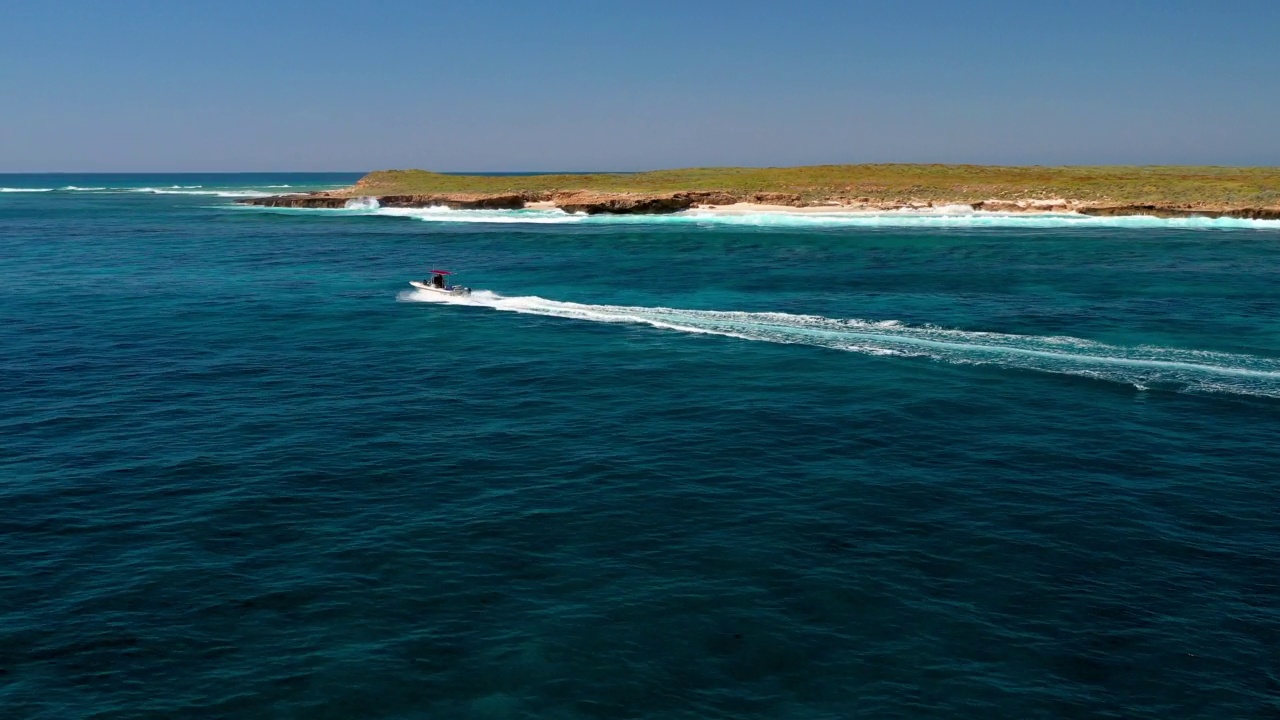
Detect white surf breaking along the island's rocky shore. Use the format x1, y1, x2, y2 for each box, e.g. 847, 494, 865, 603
247, 199, 1280, 229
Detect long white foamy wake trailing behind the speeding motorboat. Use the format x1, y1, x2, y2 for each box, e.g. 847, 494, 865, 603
399, 291, 1280, 398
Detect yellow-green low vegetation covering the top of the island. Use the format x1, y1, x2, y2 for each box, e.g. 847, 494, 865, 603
358, 165, 1280, 208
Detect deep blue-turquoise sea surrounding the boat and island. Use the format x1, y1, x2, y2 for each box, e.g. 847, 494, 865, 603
0, 176, 1280, 719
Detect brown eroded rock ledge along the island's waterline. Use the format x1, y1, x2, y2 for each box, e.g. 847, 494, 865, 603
238, 188, 1280, 220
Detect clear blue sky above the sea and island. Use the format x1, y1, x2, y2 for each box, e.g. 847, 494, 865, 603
0, 0, 1280, 172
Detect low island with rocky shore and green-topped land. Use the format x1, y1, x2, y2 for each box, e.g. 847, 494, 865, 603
239, 164, 1280, 219
